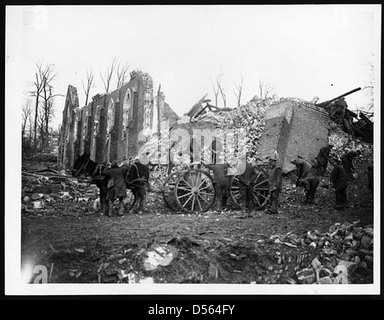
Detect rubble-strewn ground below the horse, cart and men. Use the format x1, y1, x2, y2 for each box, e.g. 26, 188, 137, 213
21, 149, 374, 285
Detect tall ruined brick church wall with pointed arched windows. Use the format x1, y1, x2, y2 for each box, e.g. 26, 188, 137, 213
58, 70, 178, 169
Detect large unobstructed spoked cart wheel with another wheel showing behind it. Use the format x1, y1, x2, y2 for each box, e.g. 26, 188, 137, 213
175, 170, 216, 212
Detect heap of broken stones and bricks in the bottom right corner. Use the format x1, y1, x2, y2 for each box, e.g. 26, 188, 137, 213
257, 221, 373, 284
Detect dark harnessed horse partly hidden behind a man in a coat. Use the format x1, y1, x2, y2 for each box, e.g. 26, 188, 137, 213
71, 153, 149, 212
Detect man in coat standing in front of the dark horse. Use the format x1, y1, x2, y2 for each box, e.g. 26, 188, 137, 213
103, 160, 128, 217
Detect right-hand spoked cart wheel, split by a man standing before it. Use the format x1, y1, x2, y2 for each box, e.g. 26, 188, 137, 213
229, 170, 269, 210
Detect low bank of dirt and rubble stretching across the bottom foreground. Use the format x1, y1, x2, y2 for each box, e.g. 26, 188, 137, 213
70, 221, 373, 284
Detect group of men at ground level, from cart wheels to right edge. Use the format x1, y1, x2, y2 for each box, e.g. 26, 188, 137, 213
208, 145, 373, 215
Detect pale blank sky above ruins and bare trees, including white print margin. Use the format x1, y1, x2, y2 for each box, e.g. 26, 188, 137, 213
6, 5, 381, 127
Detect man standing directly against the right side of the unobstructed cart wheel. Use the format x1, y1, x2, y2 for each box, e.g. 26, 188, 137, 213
207, 163, 229, 211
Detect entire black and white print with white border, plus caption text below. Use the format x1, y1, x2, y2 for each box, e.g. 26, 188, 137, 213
4, 4, 382, 298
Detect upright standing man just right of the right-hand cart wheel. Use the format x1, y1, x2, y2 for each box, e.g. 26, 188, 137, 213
266, 153, 283, 214
